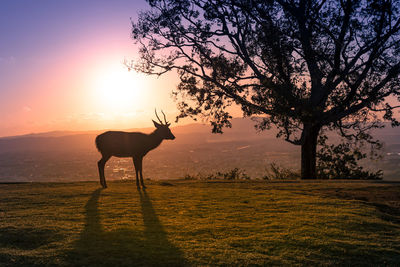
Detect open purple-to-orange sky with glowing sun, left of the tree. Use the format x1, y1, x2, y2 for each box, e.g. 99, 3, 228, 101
0, 0, 178, 136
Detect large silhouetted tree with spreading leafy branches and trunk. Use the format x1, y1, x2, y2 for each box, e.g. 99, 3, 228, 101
131, 0, 400, 179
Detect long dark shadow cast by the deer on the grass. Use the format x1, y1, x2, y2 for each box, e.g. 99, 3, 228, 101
68, 189, 187, 266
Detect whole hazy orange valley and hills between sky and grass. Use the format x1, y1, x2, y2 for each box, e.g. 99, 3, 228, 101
0, 119, 400, 182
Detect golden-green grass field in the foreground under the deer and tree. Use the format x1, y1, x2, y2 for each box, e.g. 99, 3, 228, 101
0, 181, 400, 266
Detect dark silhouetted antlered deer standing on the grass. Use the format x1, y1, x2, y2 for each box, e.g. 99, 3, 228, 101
95, 110, 175, 189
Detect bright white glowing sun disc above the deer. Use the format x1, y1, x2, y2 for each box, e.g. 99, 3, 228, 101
93, 66, 147, 113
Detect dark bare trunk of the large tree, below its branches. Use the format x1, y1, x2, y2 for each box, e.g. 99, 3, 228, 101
301, 124, 321, 179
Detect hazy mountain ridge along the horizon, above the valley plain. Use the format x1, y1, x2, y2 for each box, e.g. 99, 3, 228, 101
0, 119, 282, 153
